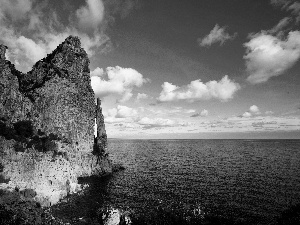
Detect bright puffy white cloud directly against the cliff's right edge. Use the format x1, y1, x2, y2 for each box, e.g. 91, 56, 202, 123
91, 66, 149, 102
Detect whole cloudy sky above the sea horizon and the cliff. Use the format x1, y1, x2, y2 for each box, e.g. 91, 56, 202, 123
0, 0, 300, 139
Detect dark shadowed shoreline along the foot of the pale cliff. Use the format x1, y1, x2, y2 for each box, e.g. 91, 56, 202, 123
0, 164, 125, 225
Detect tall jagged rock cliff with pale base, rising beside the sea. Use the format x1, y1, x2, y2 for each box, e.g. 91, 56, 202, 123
0, 36, 111, 205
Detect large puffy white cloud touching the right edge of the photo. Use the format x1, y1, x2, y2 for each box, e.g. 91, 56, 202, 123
244, 31, 300, 84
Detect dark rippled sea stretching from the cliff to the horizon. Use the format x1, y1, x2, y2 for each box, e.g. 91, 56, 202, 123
51, 139, 300, 225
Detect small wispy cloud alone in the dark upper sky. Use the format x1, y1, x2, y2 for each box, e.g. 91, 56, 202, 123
198, 24, 237, 47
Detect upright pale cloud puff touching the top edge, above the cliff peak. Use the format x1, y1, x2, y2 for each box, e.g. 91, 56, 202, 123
76, 0, 104, 30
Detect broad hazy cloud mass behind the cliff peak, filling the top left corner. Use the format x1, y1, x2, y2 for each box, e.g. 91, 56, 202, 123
0, 0, 135, 72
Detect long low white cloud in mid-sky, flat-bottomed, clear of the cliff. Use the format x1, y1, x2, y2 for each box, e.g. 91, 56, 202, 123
157, 75, 240, 102
